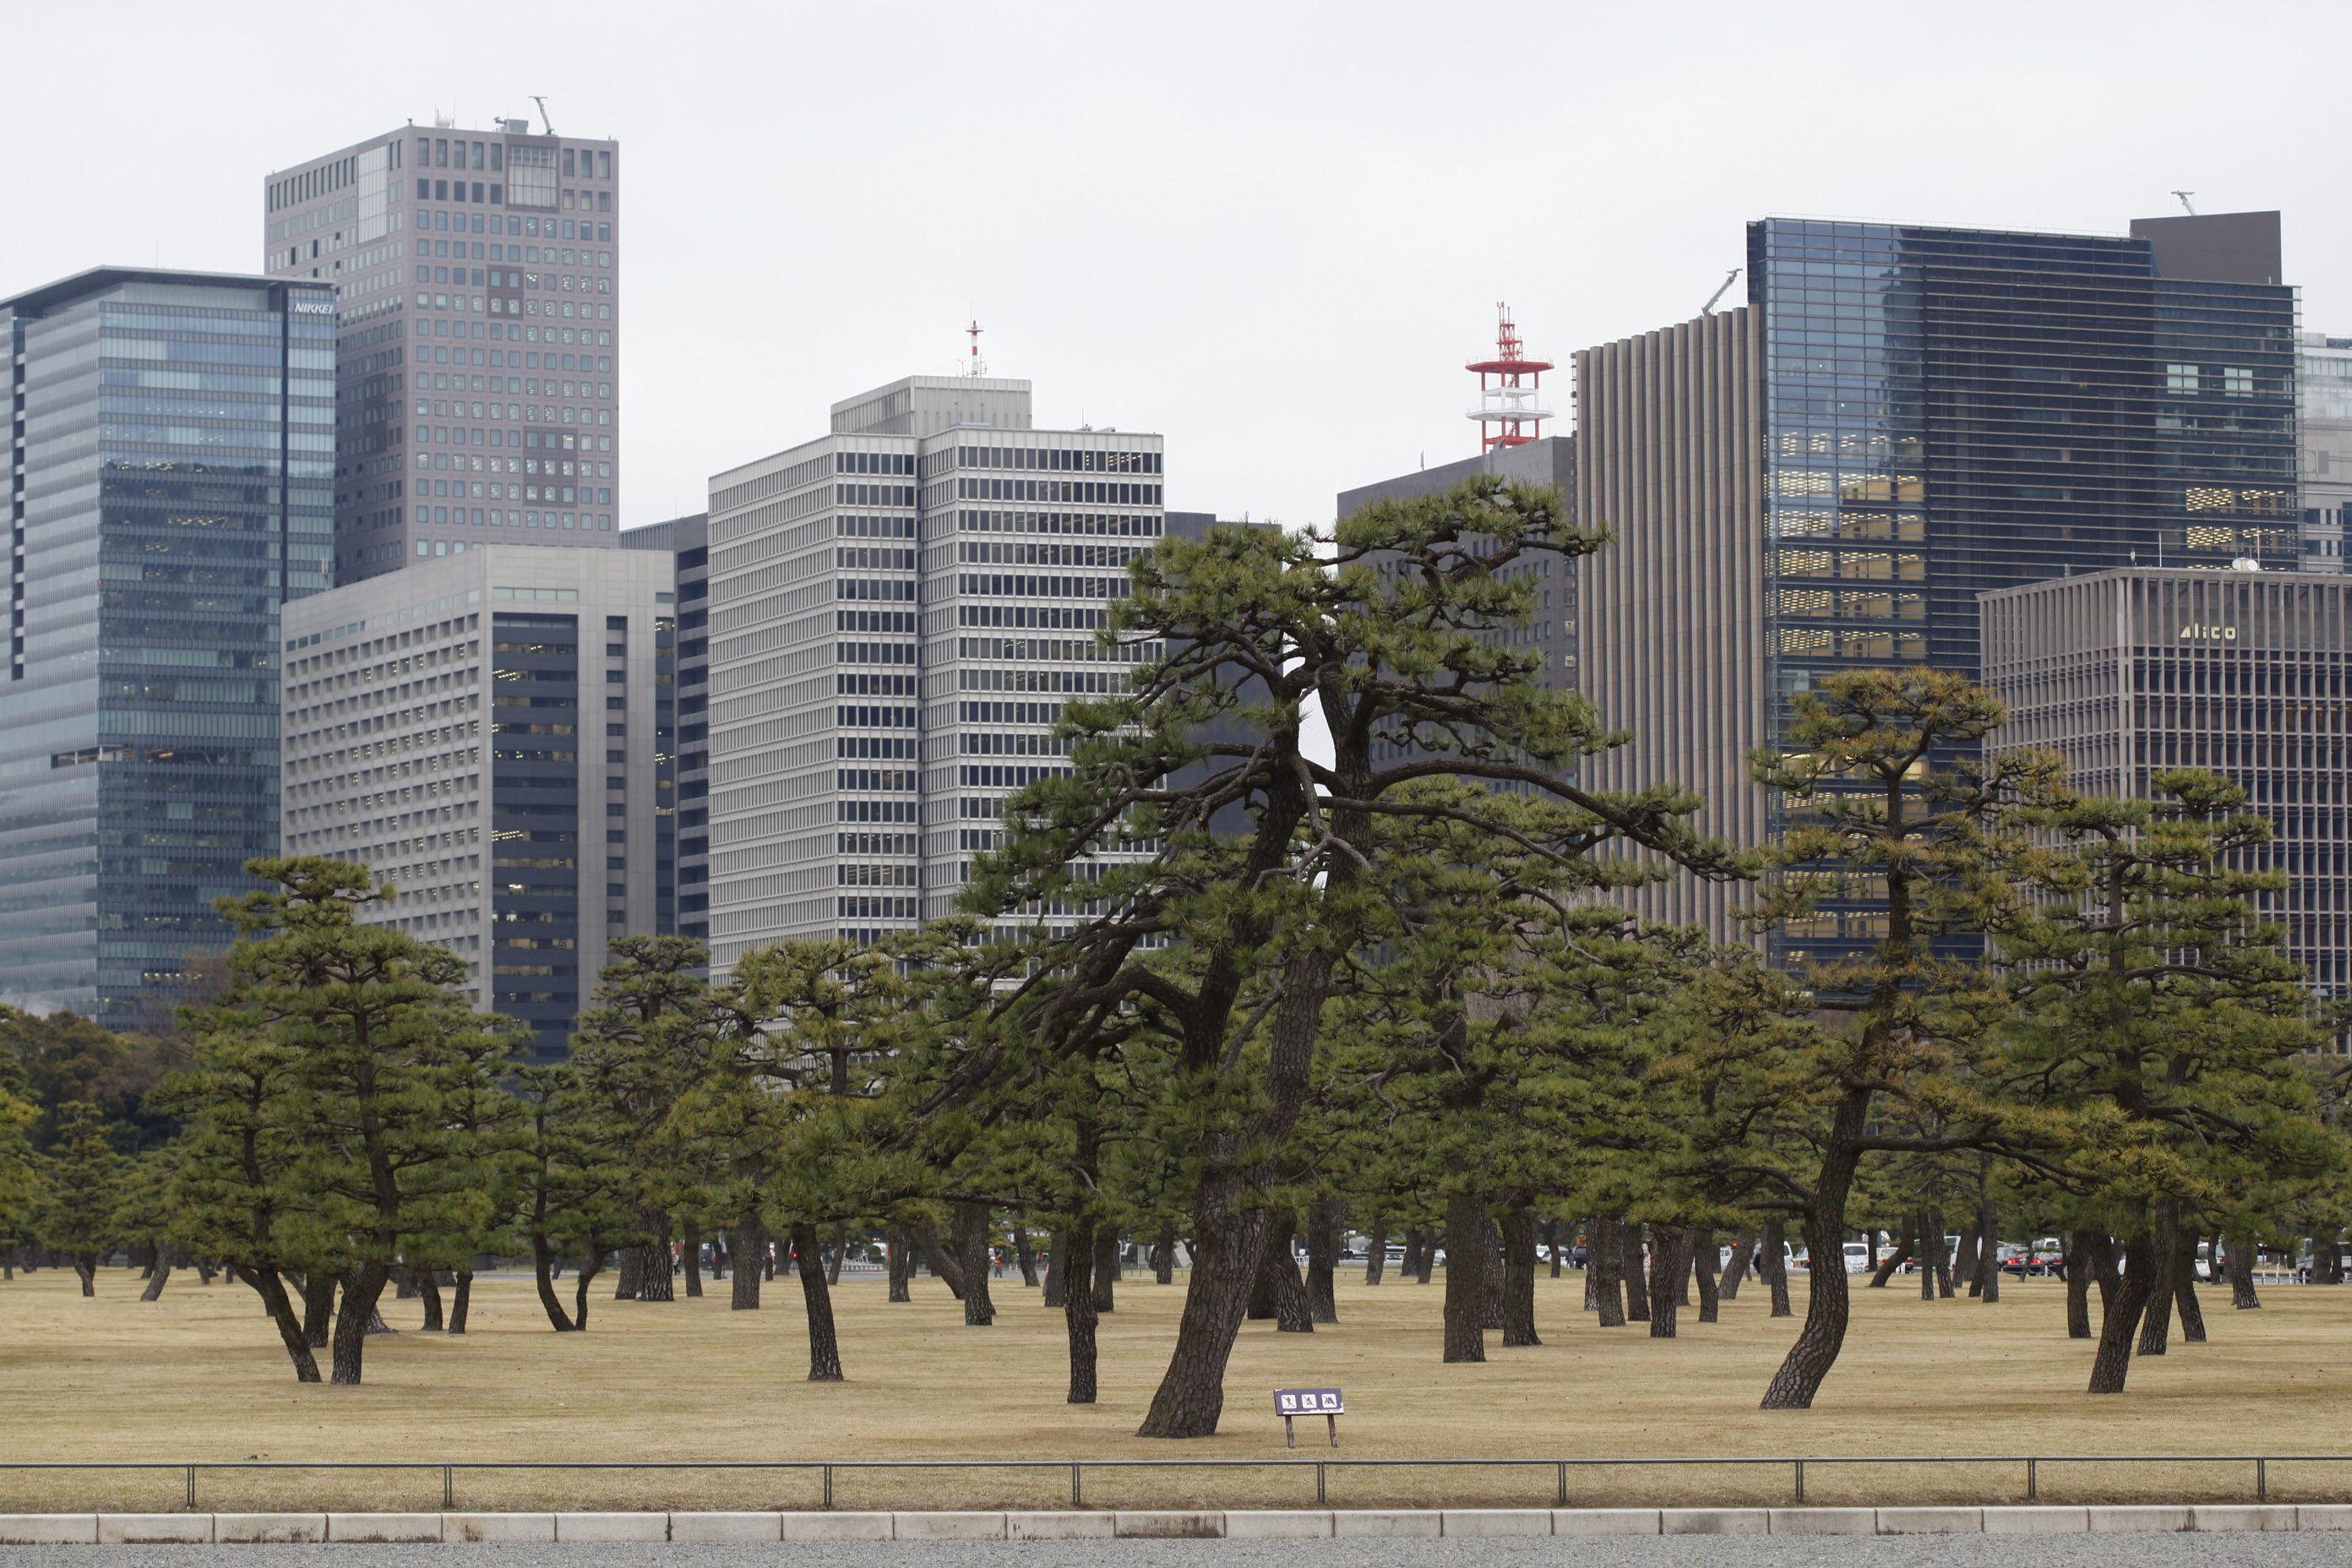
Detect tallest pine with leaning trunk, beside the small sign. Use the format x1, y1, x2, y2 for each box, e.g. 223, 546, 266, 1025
945, 477, 1731, 1436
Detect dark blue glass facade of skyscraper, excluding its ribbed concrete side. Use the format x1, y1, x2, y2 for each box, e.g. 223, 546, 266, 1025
1748, 219, 2300, 957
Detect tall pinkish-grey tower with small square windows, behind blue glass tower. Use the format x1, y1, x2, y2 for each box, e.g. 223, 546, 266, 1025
261, 120, 623, 583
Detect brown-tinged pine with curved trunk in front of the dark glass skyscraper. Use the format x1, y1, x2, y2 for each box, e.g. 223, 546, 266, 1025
1721, 670, 2061, 1411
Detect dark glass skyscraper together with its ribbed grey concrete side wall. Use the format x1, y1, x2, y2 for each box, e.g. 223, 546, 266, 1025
1576, 214, 2300, 952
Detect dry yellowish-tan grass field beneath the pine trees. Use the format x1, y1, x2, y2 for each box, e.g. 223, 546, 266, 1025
0, 1270, 2352, 1511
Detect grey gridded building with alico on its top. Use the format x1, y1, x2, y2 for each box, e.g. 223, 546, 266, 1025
1983, 567, 2352, 999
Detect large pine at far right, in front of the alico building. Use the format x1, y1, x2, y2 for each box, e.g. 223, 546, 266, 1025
1987, 769, 2343, 1394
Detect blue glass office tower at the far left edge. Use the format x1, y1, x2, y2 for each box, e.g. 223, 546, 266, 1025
0, 268, 336, 1027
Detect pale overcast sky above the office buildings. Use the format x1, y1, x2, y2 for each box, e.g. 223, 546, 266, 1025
0, 0, 2352, 526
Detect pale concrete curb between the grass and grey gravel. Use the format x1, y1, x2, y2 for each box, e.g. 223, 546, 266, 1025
0, 1502, 2352, 1547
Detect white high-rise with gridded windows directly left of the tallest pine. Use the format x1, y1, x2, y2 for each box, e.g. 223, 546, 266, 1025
708, 376, 1164, 971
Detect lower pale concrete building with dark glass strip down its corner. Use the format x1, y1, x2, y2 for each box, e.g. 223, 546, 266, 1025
280, 546, 678, 1058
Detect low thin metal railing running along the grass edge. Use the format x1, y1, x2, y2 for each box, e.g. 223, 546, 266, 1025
0, 1453, 2352, 1509
